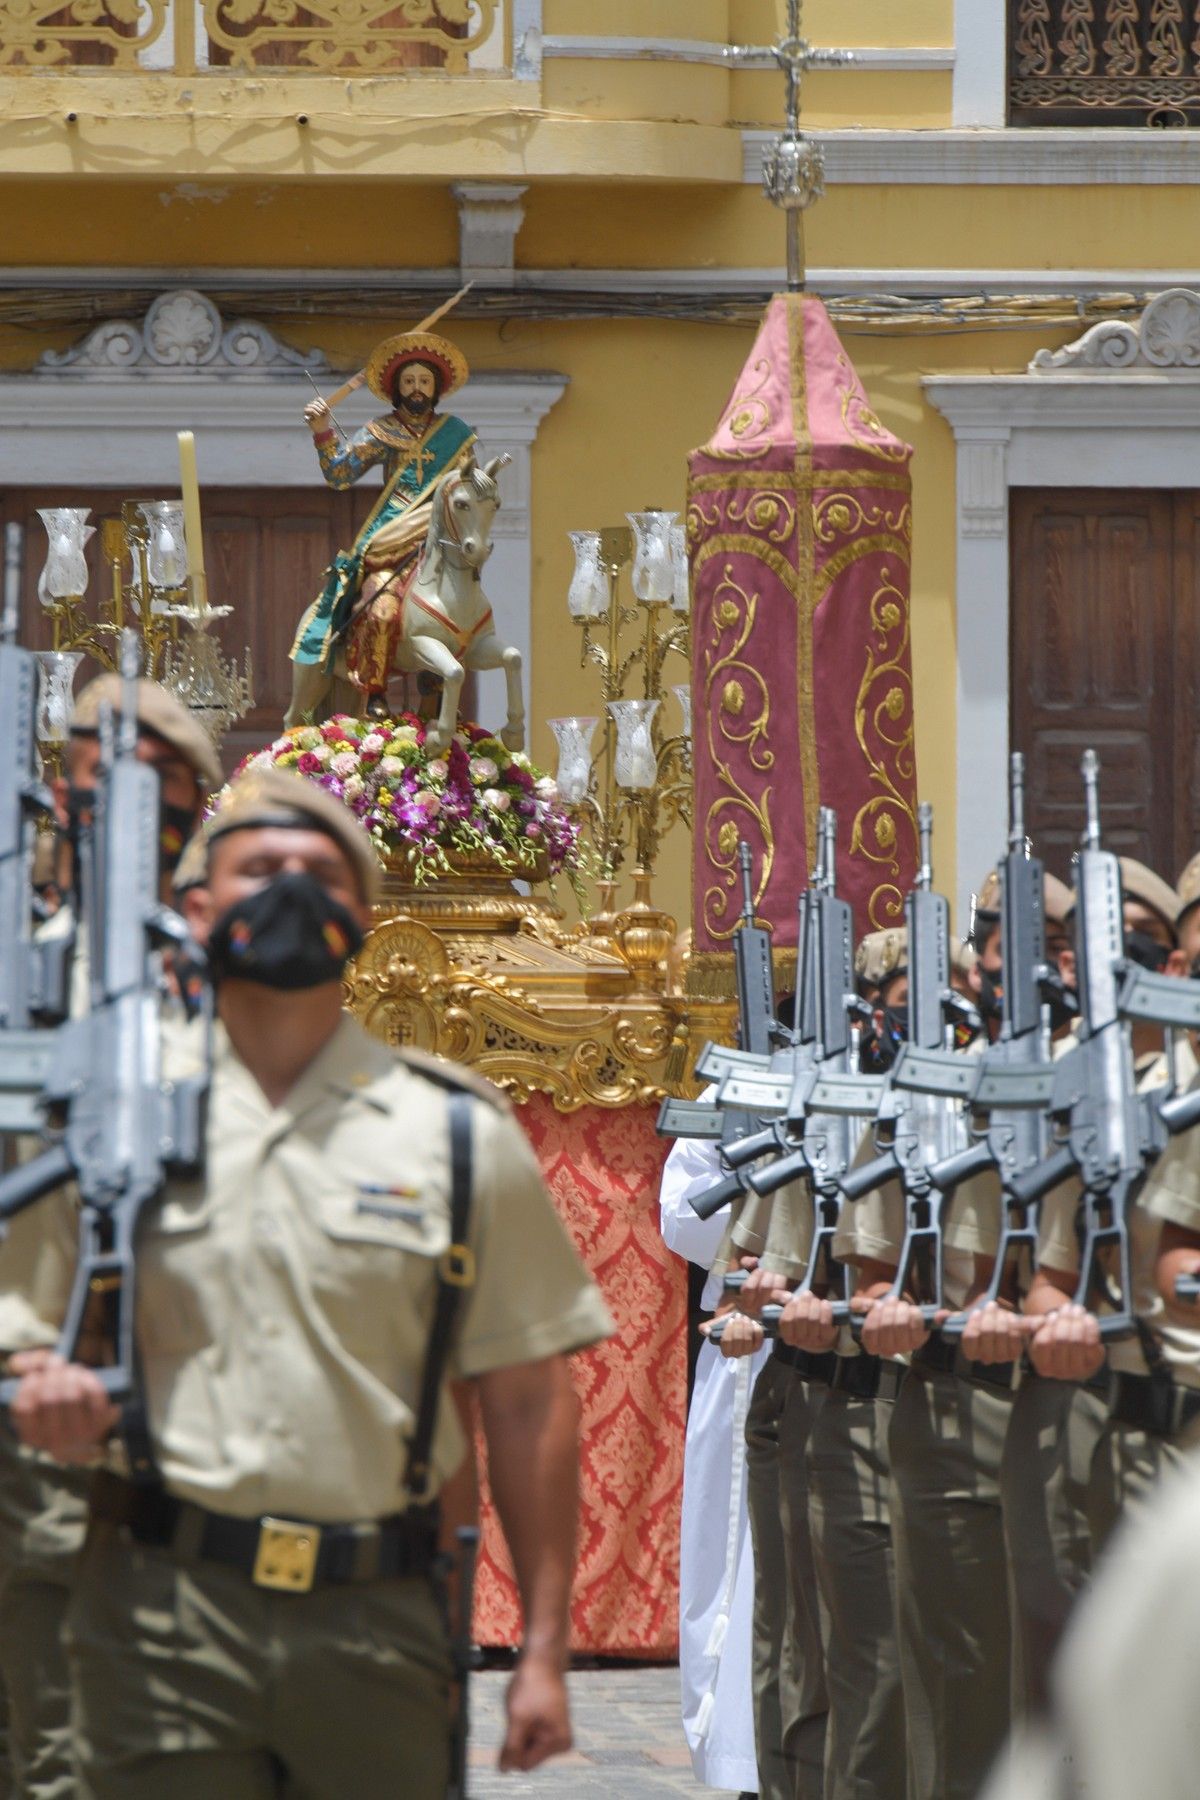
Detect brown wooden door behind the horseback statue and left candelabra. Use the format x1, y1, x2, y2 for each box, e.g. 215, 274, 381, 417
0, 482, 475, 770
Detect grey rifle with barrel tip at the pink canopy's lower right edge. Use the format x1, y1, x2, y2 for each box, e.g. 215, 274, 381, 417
842, 805, 977, 1325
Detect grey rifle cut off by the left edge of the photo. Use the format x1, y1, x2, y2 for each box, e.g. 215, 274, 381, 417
0, 524, 70, 1134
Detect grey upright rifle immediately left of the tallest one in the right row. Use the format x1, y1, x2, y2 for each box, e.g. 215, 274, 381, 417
930, 754, 1054, 1337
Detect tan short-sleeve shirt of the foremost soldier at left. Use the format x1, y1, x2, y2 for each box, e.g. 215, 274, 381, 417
26, 1019, 612, 1521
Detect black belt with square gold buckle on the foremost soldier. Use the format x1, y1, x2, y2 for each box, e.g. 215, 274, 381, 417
92, 1471, 437, 1593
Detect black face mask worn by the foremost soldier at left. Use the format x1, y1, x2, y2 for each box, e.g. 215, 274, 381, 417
209, 873, 362, 994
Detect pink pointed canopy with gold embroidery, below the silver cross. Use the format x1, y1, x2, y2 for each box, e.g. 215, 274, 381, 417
687, 293, 916, 974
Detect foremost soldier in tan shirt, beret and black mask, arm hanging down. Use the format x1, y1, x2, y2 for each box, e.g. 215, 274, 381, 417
13, 772, 612, 1800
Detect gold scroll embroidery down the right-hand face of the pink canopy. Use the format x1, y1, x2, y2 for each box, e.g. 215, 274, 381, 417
849, 565, 916, 931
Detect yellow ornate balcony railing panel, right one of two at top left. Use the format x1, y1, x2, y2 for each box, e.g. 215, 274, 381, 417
201, 0, 498, 74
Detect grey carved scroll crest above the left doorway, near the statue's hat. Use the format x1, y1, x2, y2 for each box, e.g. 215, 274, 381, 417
34, 288, 329, 378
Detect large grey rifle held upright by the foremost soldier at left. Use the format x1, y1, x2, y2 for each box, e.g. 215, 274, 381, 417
0, 632, 209, 1447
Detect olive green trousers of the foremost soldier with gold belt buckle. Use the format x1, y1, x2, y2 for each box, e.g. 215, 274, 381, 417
67, 1525, 452, 1800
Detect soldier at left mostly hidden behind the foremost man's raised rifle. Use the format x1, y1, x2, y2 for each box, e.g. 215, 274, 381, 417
0, 675, 221, 1800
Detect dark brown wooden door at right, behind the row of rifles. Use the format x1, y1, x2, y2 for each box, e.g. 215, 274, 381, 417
1009, 488, 1200, 880
